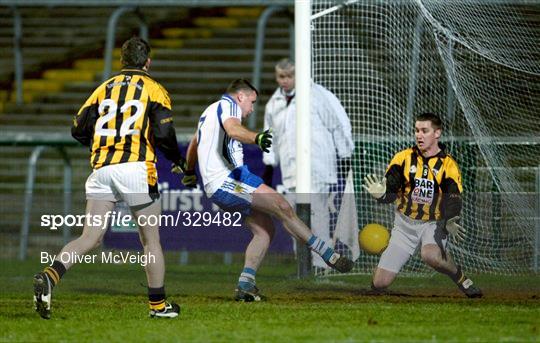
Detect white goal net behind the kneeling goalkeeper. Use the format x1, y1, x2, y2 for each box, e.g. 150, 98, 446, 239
312, 0, 540, 274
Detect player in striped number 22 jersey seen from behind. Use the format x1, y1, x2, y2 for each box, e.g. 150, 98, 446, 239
34, 37, 185, 319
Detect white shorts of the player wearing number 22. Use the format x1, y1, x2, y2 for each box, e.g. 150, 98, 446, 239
86, 162, 159, 207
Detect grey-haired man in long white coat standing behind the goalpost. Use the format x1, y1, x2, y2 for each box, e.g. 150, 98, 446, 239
263, 58, 354, 268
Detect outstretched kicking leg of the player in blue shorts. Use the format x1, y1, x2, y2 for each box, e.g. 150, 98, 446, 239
252, 184, 353, 273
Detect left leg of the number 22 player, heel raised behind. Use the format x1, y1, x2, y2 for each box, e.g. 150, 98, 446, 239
34, 199, 114, 319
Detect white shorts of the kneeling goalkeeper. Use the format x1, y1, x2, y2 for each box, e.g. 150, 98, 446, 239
378, 211, 448, 273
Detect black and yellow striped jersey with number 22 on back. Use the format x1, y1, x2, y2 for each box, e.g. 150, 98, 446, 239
71, 69, 183, 169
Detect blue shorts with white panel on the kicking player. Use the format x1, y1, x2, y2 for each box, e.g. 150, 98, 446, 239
210, 166, 263, 217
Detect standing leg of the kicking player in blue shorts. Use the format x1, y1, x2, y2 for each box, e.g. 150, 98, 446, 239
235, 210, 275, 302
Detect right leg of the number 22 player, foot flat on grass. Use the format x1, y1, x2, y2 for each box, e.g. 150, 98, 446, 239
131, 200, 180, 318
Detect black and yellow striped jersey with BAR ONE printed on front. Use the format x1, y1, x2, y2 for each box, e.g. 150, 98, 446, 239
379, 143, 463, 221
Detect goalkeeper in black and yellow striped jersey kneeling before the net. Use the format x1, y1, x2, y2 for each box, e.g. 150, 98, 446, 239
363, 113, 482, 298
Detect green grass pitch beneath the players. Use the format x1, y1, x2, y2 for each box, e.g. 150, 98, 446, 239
0, 260, 540, 342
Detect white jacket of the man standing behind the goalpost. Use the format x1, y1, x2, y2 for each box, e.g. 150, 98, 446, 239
263, 83, 354, 191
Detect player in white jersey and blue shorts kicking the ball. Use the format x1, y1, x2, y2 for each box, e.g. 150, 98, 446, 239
178, 79, 353, 302
